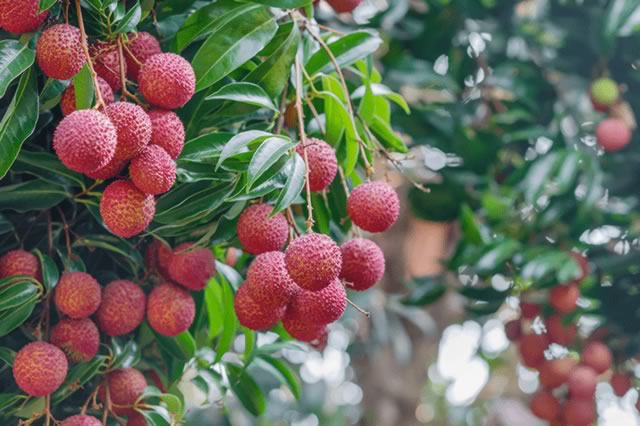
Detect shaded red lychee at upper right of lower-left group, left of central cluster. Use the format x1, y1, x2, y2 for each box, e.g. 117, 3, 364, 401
169, 243, 216, 290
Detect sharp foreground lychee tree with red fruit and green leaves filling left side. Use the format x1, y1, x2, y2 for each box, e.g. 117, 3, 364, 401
0, 0, 408, 426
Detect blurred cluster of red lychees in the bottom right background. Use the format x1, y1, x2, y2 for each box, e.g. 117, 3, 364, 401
505, 253, 632, 426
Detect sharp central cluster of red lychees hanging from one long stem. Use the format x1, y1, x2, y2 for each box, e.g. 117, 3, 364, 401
235, 138, 400, 343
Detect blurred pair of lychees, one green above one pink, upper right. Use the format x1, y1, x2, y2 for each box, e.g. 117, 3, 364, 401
590, 77, 631, 152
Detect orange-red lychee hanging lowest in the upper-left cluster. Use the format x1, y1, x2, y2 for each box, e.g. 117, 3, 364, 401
100, 180, 156, 238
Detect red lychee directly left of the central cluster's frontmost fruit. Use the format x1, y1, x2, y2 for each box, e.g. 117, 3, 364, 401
246, 251, 297, 309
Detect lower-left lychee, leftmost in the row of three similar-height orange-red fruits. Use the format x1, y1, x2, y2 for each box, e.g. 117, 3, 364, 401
54, 272, 102, 319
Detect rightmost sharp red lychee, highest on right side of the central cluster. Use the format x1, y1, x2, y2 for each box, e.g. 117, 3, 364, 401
347, 182, 400, 232
